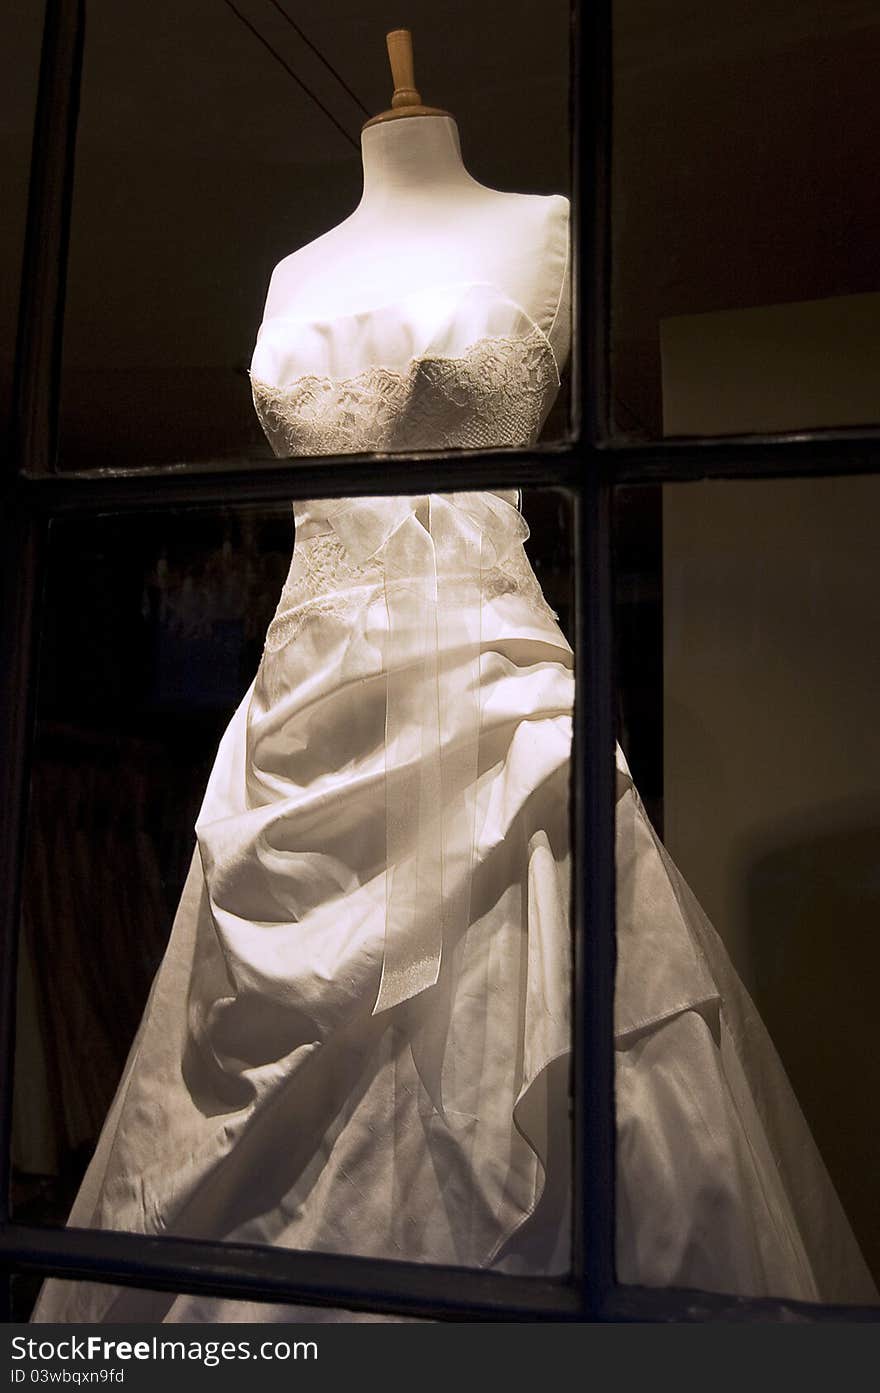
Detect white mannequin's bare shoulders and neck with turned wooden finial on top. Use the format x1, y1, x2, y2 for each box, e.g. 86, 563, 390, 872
252, 31, 571, 376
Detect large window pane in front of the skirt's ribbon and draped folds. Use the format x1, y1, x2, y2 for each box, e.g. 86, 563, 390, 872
14, 490, 574, 1321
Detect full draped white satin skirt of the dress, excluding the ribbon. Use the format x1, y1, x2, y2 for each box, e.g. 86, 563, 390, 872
32, 573, 876, 1322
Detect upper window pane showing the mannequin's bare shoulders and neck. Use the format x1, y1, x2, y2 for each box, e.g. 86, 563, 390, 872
60, 0, 569, 469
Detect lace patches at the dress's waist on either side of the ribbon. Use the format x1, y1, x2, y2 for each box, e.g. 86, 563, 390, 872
265, 532, 558, 653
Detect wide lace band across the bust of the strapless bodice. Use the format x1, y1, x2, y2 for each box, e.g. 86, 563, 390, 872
249, 326, 558, 457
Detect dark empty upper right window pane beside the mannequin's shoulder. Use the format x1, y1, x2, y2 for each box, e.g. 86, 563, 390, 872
613, 0, 880, 440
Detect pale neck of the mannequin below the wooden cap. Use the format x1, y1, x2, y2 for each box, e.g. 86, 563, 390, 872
358, 116, 480, 213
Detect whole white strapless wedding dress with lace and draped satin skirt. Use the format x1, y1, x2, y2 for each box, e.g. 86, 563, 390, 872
32, 284, 876, 1322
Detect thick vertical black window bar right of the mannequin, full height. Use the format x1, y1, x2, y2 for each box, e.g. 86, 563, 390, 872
572, 0, 615, 1319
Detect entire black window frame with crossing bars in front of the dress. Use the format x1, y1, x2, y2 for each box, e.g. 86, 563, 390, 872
0, 0, 880, 1322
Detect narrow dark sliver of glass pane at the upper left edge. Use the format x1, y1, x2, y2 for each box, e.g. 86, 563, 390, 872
0, 0, 43, 449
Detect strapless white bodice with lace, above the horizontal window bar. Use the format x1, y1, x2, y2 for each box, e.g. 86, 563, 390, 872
251, 283, 560, 457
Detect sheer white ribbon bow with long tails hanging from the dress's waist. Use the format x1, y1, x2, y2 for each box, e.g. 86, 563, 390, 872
323, 493, 529, 1015
